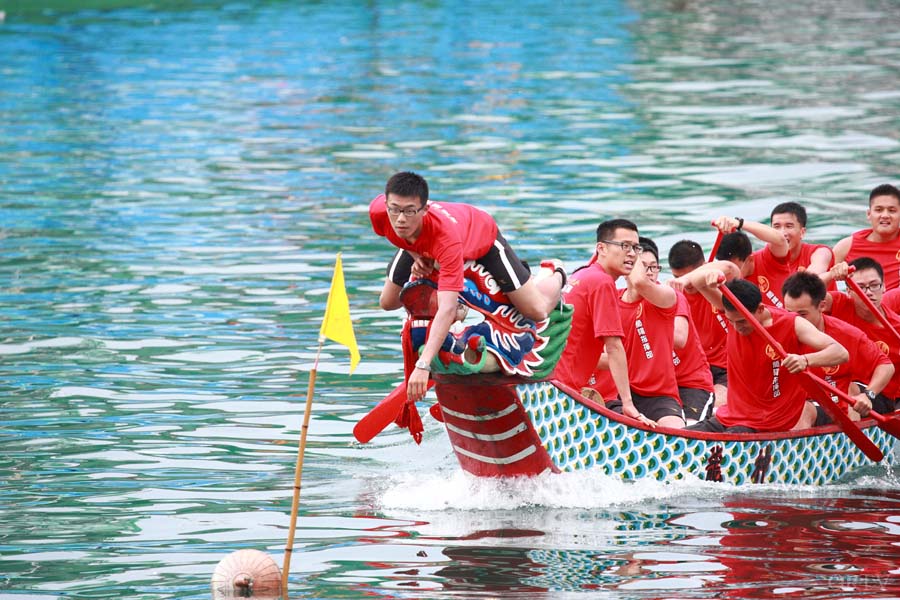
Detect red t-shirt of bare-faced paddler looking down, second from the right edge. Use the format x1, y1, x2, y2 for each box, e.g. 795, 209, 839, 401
803, 315, 891, 392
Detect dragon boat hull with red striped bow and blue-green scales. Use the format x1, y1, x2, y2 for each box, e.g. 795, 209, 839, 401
435, 375, 895, 485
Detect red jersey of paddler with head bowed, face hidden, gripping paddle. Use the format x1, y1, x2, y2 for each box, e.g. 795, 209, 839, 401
716, 307, 807, 431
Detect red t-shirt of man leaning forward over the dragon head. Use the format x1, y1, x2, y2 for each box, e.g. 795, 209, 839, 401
369, 194, 497, 292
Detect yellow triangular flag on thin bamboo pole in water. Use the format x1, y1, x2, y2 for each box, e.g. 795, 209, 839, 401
281, 252, 359, 599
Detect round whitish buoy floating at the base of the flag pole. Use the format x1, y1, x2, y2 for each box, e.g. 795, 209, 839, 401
212, 550, 282, 600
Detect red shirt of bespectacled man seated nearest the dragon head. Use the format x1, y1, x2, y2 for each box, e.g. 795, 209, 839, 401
553, 263, 622, 390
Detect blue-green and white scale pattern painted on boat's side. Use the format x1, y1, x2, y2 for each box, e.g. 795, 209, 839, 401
517, 382, 894, 485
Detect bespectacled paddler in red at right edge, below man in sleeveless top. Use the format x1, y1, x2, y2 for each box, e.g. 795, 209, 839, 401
820, 256, 900, 414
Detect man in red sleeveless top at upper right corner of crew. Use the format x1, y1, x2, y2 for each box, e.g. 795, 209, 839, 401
834, 183, 900, 290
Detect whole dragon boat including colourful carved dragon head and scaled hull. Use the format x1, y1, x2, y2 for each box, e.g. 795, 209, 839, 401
354, 263, 896, 485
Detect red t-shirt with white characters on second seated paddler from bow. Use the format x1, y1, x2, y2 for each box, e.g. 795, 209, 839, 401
619, 290, 681, 402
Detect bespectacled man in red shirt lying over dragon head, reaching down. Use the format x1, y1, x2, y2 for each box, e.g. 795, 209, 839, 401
369, 171, 565, 401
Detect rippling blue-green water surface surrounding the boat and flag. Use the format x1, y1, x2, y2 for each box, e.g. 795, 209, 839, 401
0, 0, 900, 600
